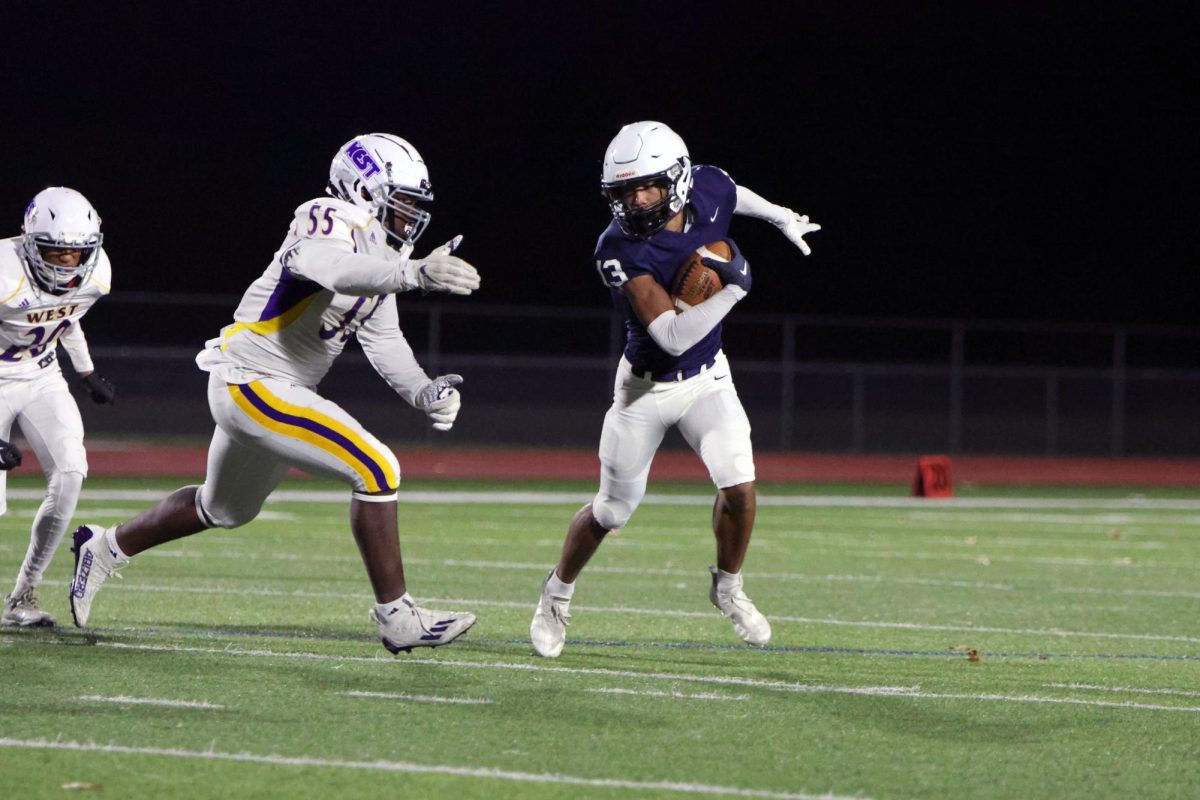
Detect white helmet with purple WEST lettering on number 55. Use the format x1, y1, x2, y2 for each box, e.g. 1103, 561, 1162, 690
329, 133, 433, 249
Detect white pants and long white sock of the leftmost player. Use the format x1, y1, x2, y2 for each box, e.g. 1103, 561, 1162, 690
0, 368, 88, 590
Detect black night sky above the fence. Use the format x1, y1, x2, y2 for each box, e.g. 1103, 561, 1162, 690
0, 0, 1200, 328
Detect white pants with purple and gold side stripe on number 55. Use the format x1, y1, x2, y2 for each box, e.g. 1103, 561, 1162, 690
197, 375, 400, 528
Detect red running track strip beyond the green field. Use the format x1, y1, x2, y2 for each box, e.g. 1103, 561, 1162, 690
14, 441, 1200, 487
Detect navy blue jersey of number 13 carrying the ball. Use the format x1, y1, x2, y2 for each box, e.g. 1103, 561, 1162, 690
595, 164, 738, 372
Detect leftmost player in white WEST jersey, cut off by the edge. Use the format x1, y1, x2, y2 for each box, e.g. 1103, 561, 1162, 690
0, 186, 115, 627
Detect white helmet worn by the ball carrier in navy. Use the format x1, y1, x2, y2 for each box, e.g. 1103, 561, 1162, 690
600, 121, 691, 239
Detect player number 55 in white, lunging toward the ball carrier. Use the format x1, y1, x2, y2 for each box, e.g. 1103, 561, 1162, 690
71, 133, 479, 652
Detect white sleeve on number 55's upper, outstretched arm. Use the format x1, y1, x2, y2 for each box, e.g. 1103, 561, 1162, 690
287, 239, 419, 295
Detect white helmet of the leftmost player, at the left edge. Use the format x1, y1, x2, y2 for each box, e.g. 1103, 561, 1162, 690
22, 186, 104, 295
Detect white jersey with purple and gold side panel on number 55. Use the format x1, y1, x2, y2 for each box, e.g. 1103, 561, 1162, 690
197, 198, 428, 402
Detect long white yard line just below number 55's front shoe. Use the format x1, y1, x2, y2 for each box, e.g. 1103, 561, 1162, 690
82, 642, 1200, 714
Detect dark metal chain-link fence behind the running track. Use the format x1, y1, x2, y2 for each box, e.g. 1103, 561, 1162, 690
75, 293, 1200, 456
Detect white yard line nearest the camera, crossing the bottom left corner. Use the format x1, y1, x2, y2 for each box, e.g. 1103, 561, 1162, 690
0, 738, 869, 800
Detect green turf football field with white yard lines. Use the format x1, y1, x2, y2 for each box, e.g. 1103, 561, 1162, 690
0, 480, 1200, 800
